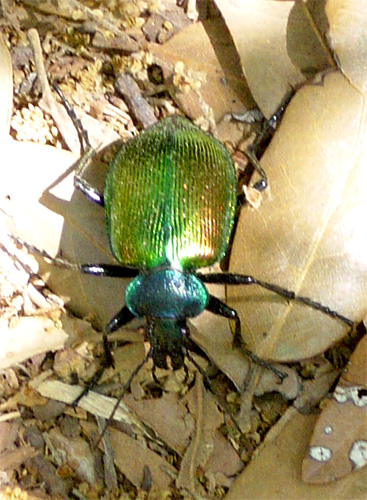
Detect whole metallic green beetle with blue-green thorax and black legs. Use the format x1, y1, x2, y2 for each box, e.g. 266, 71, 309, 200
17, 87, 353, 400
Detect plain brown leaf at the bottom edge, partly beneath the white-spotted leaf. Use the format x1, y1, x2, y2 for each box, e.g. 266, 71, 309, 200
226, 408, 367, 500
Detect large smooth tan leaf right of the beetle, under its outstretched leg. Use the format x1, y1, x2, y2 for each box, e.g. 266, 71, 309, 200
228, 73, 367, 361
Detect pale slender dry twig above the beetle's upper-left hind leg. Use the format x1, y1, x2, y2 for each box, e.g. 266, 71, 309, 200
27, 28, 80, 154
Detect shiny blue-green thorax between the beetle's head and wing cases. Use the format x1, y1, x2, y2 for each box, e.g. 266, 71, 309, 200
125, 267, 208, 320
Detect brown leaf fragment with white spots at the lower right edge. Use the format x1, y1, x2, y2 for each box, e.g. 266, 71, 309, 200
302, 336, 367, 483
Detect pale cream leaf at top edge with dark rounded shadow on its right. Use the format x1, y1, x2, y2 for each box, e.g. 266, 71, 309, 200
216, 0, 335, 118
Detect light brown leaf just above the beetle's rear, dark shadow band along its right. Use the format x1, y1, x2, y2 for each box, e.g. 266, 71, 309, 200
149, 21, 253, 121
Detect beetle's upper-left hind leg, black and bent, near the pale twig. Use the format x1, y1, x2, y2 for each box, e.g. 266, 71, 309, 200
53, 84, 104, 207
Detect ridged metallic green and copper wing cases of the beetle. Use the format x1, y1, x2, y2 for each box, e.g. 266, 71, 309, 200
105, 117, 237, 269
